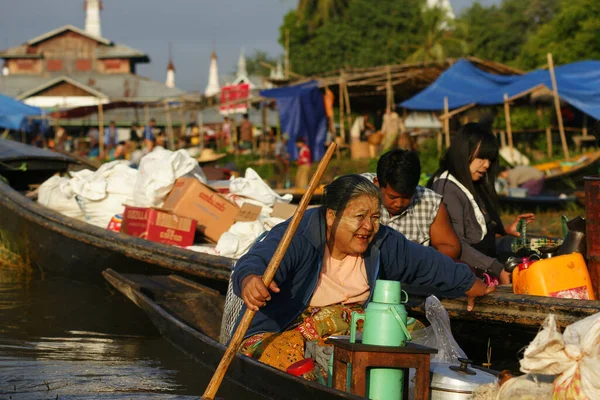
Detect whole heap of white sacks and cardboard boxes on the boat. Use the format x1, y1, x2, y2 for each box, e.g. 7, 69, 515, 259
38, 150, 295, 258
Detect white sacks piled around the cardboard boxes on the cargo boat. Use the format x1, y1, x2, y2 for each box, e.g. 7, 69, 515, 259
38, 149, 292, 258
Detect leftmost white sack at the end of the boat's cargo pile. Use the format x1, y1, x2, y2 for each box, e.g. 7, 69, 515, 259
37, 175, 83, 220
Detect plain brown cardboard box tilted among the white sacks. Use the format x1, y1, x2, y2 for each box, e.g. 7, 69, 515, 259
162, 177, 260, 242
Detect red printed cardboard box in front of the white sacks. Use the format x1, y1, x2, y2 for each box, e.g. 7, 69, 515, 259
121, 205, 196, 247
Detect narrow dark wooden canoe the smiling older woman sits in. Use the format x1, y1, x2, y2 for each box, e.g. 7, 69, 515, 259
103, 269, 362, 400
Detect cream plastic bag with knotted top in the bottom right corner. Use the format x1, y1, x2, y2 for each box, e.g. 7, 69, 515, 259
520, 313, 600, 400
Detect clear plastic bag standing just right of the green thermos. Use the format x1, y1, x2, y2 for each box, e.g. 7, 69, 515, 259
412, 295, 467, 364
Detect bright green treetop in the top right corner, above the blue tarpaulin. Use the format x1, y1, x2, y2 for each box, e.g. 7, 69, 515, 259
519, 0, 600, 68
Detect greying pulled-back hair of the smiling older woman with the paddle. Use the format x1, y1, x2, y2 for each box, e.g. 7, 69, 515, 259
321, 174, 381, 213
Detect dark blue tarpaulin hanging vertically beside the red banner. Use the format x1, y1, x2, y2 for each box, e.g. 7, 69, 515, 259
260, 81, 327, 161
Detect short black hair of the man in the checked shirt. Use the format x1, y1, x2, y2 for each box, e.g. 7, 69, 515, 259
377, 149, 421, 196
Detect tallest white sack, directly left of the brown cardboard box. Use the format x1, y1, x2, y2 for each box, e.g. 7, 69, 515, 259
133, 149, 207, 207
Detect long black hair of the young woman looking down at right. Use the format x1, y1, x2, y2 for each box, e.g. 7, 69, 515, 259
427, 122, 500, 227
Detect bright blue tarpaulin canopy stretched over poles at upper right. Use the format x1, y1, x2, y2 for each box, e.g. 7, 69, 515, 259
398, 60, 600, 119
